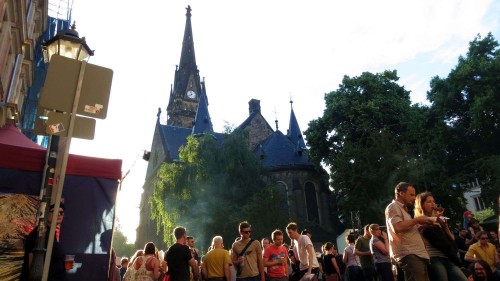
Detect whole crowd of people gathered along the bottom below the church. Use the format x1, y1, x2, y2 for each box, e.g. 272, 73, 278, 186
113, 182, 500, 281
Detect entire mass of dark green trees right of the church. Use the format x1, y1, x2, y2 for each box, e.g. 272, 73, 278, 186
305, 34, 500, 226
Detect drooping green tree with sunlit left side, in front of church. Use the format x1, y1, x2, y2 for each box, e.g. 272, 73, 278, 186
150, 132, 287, 251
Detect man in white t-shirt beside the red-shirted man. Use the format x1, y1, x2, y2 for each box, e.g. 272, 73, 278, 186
286, 222, 319, 278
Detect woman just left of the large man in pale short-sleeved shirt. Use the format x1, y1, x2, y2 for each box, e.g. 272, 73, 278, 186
369, 224, 394, 281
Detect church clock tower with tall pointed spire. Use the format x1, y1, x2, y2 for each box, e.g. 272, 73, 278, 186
167, 6, 204, 128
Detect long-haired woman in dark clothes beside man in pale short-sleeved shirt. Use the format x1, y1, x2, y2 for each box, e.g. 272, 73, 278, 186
415, 192, 467, 281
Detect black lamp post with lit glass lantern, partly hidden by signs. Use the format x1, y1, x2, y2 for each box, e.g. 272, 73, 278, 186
29, 23, 94, 281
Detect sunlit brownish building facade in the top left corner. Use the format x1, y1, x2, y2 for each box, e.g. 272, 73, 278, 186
0, 0, 48, 127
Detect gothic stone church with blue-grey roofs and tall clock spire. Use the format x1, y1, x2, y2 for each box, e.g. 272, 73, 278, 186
136, 6, 333, 249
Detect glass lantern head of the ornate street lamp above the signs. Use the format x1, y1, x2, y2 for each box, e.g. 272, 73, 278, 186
42, 22, 94, 63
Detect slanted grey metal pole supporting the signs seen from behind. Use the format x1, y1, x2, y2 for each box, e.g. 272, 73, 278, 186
42, 61, 87, 281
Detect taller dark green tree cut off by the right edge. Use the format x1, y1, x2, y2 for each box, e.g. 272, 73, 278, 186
428, 33, 500, 206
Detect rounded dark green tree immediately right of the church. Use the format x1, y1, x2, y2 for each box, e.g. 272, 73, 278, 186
305, 71, 418, 225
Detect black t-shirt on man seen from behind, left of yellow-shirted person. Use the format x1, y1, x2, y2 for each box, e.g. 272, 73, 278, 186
165, 243, 193, 281
